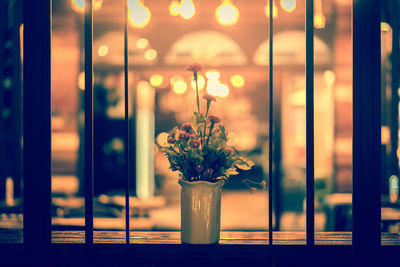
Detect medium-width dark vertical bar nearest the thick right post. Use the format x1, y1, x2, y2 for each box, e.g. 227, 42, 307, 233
306, 0, 314, 245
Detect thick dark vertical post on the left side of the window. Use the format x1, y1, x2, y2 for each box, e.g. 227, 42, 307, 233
23, 0, 51, 251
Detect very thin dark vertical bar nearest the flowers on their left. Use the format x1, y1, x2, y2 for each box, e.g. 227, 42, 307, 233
124, 0, 130, 244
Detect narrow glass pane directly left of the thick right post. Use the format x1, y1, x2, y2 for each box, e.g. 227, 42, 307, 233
314, 0, 353, 245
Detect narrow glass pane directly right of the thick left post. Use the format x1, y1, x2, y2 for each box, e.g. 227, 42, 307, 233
51, 1, 85, 245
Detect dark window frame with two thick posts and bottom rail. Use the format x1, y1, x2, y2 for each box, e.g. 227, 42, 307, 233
12, 0, 397, 263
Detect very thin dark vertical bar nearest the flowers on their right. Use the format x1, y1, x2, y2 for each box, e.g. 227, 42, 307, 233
268, 0, 274, 245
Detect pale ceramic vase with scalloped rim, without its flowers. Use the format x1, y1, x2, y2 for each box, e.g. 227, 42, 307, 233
178, 179, 225, 244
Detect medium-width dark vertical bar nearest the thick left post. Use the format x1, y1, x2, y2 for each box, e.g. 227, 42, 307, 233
85, 0, 94, 244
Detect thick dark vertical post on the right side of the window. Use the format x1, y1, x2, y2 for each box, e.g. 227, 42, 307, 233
353, 0, 381, 258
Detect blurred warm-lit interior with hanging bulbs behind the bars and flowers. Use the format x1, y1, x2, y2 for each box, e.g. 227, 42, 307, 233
0, 0, 400, 239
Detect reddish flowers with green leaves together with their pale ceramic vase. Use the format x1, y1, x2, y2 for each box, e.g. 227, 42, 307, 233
161, 63, 254, 244
